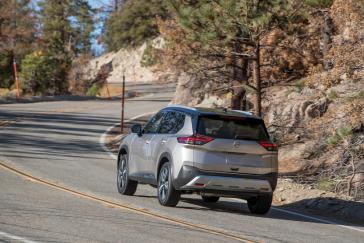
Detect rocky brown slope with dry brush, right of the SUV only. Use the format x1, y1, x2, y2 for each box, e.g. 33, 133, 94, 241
264, 0, 364, 198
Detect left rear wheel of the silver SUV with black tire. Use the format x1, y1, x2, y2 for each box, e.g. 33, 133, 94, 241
157, 162, 181, 207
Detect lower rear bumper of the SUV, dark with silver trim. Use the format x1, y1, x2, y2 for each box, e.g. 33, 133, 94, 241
173, 165, 278, 196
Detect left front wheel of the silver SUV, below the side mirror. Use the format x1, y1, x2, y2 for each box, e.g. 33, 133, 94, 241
116, 154, 138, 195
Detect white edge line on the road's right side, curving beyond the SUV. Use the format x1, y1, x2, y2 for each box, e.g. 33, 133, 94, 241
99, 112, 364, 233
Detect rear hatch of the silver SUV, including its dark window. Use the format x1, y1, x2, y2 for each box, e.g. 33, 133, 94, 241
194, 115, 277, 174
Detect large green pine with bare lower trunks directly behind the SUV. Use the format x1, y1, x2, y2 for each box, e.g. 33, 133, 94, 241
169, 0, 314, 115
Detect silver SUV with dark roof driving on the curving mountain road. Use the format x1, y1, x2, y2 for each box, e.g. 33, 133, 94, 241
117, 106, 278, 214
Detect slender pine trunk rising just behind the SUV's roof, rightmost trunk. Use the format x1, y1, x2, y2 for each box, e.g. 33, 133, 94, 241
253, 42, 262, 116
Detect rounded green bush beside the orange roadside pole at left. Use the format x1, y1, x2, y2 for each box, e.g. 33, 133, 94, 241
19, 51, 55, 95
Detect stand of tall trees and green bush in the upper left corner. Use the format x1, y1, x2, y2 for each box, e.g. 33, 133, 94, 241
0, 0, 94, 95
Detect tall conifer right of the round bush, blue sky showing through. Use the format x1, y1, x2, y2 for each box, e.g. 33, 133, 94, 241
39, 0, 93, 95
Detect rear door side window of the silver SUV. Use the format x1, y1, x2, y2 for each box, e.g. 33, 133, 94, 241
159, 111, 186, 134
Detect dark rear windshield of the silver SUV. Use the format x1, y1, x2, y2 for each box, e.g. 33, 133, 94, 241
197, 116, 269, 141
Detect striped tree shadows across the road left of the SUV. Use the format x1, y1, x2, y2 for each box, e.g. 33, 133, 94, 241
0, 110, 117, 159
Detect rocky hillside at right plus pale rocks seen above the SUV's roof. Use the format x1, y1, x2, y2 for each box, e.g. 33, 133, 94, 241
174, 0, 364, 199
